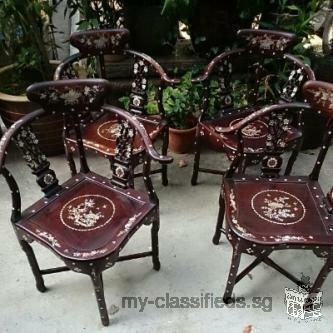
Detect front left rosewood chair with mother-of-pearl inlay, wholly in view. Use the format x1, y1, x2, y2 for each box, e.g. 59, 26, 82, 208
0, 79, 172, 326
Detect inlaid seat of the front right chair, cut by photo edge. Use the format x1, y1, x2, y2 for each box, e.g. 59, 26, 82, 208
224, 176, 333, 245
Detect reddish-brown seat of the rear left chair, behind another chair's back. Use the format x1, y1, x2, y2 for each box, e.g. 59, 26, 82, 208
66, 114, 166, 156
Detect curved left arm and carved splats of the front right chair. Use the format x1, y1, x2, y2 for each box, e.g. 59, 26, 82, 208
223, 103, 310, 178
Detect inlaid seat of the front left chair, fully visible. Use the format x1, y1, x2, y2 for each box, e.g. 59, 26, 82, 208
16, 173, 157, 260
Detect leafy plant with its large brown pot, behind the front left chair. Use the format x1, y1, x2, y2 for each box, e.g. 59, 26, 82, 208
0, 0, 63, 155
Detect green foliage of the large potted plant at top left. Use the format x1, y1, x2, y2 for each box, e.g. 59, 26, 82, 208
0, 0, 59, 80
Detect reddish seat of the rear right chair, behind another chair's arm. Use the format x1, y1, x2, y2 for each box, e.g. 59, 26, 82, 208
200, 108, 301, 158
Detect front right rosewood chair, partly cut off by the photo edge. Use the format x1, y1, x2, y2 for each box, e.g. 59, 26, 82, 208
213, 81, 333, 306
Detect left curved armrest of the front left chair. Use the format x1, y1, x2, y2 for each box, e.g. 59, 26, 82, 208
0, 109, 45, 173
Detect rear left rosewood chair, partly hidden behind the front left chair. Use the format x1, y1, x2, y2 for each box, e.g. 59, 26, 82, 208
54, 29, 177, 186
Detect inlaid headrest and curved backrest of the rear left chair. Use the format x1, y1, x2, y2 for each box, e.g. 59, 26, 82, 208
54, 29, 173, 115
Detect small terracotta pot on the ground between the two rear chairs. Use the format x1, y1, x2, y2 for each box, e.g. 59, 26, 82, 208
169, 127, 196, 154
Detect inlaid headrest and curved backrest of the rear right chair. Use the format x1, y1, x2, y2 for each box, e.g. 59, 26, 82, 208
200, 29, 314, 116
